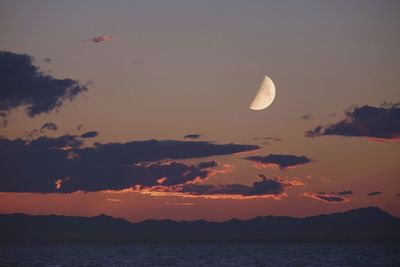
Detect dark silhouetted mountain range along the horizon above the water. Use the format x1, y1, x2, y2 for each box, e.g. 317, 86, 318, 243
0, 207, 400, 244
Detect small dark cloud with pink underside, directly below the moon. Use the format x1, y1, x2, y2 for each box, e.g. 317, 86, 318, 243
244, 154, 312, 170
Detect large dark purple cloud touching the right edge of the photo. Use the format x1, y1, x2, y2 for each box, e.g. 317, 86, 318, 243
305, 104, 400, 141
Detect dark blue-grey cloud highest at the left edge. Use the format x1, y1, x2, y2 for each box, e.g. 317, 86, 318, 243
0, 51, 88, 117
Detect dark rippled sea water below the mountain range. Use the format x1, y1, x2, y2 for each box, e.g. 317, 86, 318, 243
0, 244, 400, 267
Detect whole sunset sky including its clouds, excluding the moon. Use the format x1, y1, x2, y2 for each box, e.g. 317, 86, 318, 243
0, 0, 400, 221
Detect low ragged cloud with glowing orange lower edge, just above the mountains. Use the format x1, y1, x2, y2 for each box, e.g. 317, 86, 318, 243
136, 175, 303, 199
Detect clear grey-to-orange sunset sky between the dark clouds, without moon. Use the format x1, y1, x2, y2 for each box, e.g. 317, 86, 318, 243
0, 0, 400, 221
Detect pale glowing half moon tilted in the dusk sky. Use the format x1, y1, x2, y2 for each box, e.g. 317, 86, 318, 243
249, 76, 276, 110
